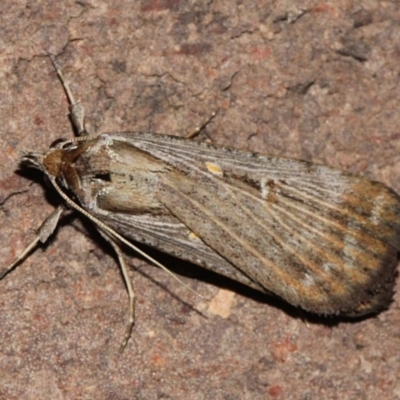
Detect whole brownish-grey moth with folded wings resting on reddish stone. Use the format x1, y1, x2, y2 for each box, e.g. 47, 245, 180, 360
6, 58, 400, 346
